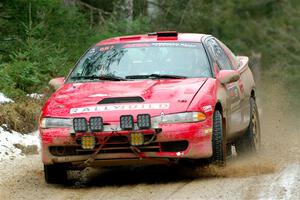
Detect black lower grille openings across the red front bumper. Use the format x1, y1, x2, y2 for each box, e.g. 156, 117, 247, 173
49, 134, 188, 156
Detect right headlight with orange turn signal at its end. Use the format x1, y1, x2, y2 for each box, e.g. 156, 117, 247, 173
153, 112, 206, 124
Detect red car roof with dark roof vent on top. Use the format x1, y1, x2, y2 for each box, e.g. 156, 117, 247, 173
96, 31, 208, 46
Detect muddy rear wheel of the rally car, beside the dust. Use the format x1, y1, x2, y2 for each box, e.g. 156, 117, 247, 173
235, 98, 261, 156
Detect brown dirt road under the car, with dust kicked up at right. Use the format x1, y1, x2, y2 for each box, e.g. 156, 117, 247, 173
0, 77, 300, 200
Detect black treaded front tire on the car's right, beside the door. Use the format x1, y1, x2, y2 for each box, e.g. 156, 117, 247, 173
211, 110, 227, 166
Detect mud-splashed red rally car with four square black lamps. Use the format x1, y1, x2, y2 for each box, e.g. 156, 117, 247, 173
39, 31, 260, 183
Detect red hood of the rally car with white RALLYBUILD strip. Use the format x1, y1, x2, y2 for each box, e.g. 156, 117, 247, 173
42, 78, 207, 121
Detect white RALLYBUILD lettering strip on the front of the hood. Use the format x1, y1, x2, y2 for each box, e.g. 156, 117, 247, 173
70, 103, 170, 114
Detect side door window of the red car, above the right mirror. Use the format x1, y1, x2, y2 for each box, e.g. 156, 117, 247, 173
207, 38, 232, 70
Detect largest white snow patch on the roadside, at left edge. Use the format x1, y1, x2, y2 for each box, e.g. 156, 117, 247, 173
0, 125, 40, 161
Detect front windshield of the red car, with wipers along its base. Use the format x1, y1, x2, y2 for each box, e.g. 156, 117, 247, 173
68, 42, 211, 82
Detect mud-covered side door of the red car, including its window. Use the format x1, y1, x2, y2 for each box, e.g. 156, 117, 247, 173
207, 38, 243, 137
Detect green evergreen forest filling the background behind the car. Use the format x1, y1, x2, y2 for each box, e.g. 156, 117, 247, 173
0, 0, 300, 103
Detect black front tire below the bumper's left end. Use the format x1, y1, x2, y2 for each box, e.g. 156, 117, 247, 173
44, 165, 68, 184
